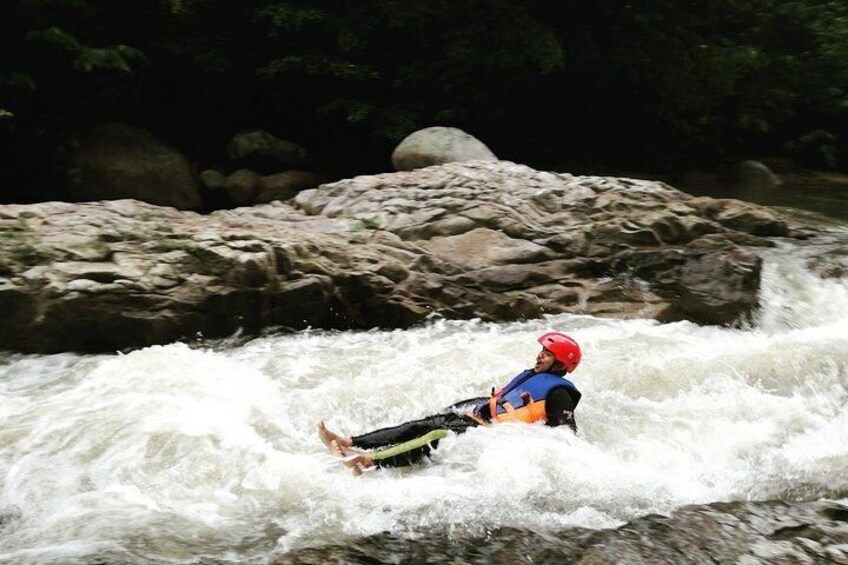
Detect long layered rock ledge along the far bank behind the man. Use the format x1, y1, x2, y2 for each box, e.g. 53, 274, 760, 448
0, 161, 811, 352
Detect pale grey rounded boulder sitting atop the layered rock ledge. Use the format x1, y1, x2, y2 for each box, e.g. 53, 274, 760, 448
392, 127, 498, 171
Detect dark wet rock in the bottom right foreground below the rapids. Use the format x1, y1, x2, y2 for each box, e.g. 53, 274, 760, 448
273, 502, 848, 565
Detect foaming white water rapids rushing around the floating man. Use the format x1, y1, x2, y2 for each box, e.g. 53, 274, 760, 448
0, 231, 848, 563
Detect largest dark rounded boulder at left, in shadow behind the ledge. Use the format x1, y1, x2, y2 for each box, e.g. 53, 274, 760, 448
71, 124, 201, 210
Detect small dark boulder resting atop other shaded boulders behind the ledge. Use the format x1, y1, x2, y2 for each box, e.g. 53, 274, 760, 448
227, 130, 307, 173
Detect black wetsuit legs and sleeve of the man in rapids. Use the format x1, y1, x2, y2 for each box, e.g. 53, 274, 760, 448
351, 387, 577, 467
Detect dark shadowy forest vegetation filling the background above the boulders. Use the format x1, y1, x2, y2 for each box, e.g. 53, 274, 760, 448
0, 0, 848, 202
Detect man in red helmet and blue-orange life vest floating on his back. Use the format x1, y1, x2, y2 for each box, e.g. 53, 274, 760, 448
318, 332, 581, 475
